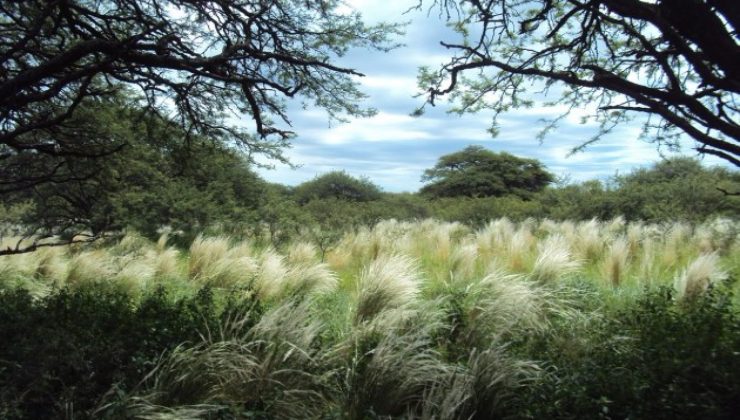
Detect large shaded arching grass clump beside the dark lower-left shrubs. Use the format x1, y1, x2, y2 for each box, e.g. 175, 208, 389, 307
121, 301, 328, 418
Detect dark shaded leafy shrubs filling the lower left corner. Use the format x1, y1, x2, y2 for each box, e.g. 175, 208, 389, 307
0, 286, 260, 419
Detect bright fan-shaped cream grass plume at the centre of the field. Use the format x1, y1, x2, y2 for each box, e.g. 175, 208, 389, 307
355, 255, 420, 323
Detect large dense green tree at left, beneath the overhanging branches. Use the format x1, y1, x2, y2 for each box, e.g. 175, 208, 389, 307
0, 100, 265, 255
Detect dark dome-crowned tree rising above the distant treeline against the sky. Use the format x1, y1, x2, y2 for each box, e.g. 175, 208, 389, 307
421, 146, 554, 198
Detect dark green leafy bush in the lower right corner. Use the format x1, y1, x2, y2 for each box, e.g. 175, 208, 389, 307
515, 286, 740, 419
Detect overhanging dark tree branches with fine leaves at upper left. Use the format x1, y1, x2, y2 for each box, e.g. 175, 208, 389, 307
0, 0, 397, 188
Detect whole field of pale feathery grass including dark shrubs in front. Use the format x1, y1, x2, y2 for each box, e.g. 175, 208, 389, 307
0, 219, 740, 419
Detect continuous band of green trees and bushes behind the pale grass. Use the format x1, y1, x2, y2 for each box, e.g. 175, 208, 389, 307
0, 98, 740, 246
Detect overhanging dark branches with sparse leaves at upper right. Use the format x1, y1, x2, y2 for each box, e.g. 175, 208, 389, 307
420, 0, 740, 166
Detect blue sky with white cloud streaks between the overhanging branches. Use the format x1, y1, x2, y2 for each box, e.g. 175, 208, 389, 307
258, 0, 723, 192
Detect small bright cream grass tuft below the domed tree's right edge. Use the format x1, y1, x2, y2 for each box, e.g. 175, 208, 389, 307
529, 234, 581, 283
